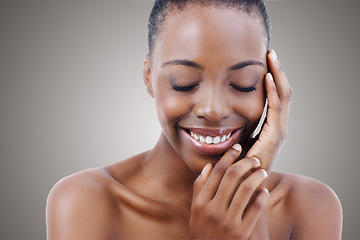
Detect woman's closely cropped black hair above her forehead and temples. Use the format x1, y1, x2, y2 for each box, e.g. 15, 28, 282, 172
148, 0, 270, 55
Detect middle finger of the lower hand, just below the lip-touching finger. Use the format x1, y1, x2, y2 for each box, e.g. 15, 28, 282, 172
214, 158, 260, 209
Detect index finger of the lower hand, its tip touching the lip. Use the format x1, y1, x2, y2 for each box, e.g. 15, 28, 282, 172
199, 144, 242, 201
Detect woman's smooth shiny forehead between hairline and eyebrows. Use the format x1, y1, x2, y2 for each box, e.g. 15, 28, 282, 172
153, 4, 266, 65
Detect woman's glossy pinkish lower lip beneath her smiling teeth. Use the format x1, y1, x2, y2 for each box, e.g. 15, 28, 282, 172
181, 129, 241, 155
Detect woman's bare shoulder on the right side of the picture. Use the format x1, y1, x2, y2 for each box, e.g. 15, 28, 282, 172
275, 173, 343, 239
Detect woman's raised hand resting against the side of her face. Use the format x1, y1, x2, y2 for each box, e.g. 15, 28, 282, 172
245, 50, 292, 172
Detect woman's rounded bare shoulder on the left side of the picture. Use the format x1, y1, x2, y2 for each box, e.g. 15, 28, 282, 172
46, 168, 116, 239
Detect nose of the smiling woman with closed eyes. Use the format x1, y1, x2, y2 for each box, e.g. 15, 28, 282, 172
193, 88, 232, 123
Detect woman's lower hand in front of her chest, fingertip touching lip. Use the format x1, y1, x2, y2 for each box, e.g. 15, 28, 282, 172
190, 144, 269, 239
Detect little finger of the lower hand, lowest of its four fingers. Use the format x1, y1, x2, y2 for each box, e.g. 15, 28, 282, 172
242, 188, 270, 230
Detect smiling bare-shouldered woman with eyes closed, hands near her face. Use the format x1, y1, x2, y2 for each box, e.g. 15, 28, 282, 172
47, 0, 342, 239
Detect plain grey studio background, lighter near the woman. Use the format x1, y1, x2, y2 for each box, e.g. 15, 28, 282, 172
0, 0, 360, 240
